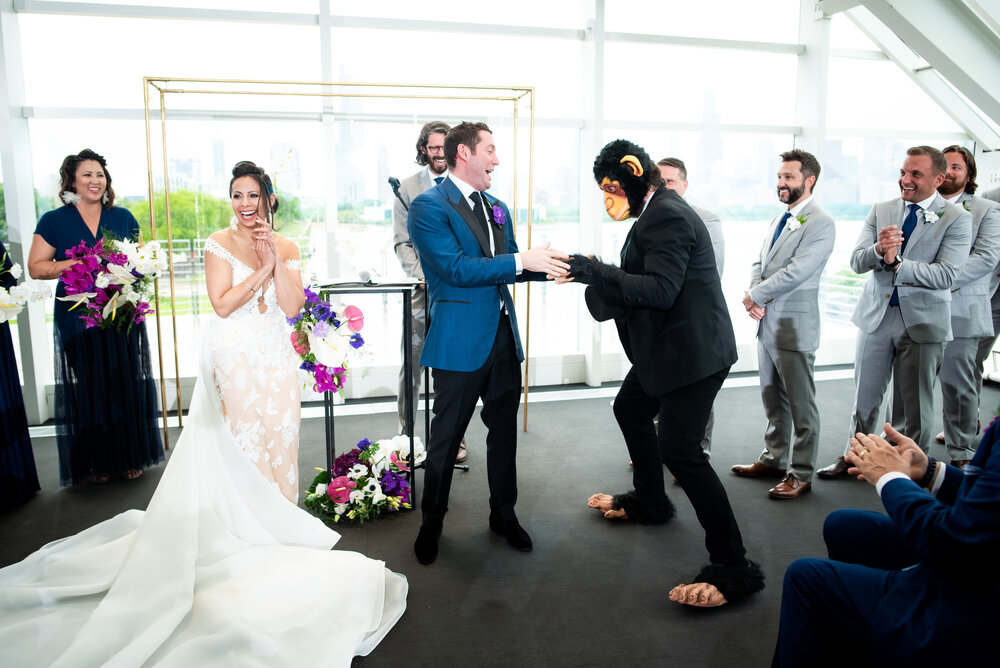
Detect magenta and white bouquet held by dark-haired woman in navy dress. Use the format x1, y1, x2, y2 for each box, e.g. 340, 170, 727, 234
59, 237, 167, 331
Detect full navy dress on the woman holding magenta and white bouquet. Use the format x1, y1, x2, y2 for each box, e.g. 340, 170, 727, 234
35, 206, 163, 485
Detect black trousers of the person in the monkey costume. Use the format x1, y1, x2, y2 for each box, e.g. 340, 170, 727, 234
614, 367, 746, 566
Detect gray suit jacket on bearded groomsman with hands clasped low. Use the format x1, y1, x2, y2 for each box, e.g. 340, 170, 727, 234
750, 200, 837, 352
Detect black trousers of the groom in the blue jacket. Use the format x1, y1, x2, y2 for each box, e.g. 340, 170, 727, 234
421, 313, 521, 526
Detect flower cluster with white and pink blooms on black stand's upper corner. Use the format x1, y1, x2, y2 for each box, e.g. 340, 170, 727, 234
287, 288, 365, 394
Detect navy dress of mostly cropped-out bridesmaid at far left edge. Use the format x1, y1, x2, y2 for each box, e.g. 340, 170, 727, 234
0, 243, 39, 509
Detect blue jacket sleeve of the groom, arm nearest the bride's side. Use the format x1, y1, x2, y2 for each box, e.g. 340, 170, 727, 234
407, 191, 517, 287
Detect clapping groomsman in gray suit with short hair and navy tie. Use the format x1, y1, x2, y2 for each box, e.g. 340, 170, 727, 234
817, 146, 972, 478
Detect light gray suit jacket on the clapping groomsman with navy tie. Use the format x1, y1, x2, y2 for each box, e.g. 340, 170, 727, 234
851, 195, 972, 343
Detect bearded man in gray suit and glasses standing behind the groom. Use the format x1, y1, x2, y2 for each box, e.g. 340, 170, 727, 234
392, 121, 468, 462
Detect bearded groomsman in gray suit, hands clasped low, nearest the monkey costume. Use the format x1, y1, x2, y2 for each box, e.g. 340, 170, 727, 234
732, 149, 837, 499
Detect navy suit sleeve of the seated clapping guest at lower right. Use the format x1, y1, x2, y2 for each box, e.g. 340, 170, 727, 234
882, 446, 1000, 572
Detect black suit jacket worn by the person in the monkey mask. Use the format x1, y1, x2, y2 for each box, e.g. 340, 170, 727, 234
599, 188, 737, 397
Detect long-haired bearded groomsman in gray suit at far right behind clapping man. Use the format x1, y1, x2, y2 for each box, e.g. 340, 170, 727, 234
920, 146, 1000, 468
